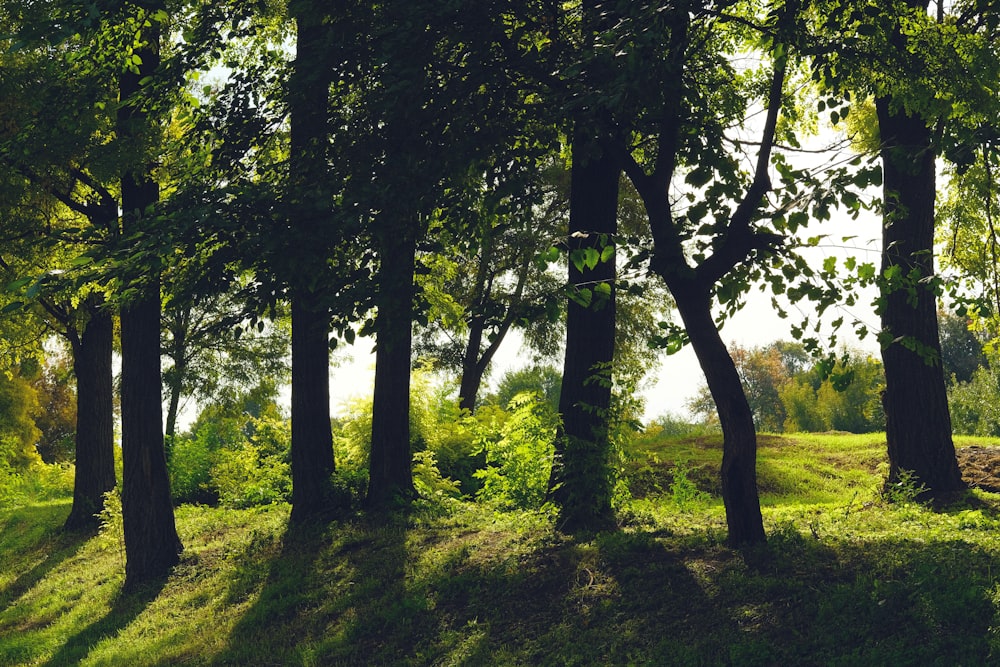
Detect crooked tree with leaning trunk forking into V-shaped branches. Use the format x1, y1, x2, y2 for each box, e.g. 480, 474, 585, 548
600, 6, 796, 545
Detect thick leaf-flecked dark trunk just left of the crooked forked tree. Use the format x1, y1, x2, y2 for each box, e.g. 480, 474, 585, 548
549, 128, 621, 532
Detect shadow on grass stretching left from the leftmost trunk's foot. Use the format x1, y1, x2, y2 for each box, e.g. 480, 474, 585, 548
0, 506, 88, 610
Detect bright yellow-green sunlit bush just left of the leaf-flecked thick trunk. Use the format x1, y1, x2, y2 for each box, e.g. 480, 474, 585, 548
475, 393, 556, 509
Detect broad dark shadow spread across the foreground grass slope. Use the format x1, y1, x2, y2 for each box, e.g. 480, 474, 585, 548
205, 508, 1000, 667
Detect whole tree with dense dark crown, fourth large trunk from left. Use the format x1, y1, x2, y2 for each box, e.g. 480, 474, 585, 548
341, 2, 556, 507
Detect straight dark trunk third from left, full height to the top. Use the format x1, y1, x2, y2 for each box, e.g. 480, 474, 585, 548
288, 1, 337, 522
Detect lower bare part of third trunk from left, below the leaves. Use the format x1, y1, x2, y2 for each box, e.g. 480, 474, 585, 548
291, 297, 335, 522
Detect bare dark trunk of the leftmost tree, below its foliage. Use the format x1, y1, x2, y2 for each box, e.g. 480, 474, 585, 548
64, 306, 116, 530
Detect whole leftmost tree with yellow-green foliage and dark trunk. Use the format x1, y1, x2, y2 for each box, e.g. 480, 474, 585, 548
0, 13, 118, 529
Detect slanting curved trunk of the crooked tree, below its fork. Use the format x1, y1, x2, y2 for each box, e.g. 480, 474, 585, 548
669, 284, 767, 547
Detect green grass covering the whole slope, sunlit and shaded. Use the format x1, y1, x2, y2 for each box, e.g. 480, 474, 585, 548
0, 435, 1000, 666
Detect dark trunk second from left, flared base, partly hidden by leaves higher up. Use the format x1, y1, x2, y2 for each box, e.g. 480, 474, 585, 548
118, 13, 181, 589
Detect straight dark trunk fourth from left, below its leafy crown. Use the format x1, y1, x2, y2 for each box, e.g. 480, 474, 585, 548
367, 223, 416, 508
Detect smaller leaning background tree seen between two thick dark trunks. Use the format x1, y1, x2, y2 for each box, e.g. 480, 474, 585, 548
416, 163, 564, 412
